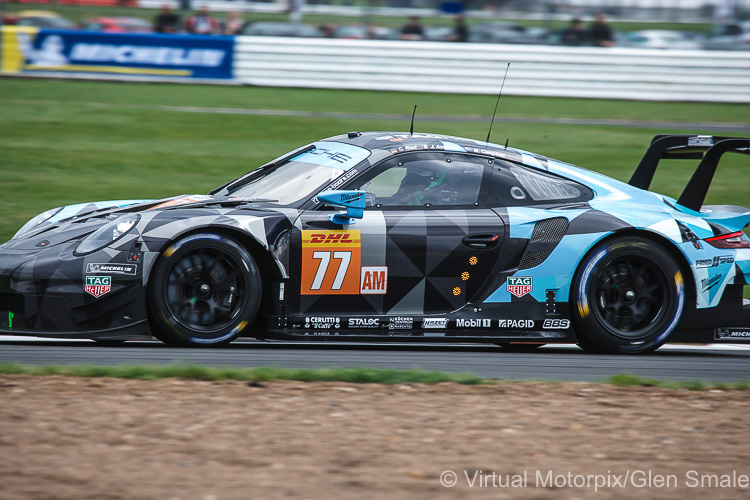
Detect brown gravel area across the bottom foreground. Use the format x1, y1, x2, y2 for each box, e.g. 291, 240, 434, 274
0, 375, 750, 500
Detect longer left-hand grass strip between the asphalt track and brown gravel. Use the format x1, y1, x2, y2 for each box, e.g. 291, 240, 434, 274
0, 363, 483, 385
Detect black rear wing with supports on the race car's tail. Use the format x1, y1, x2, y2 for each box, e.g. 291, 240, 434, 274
628, 135, 750, 212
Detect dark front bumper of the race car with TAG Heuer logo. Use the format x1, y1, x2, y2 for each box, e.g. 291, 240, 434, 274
0, 242, 149, 338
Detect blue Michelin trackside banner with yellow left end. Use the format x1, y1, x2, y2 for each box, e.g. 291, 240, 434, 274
2, 30, 234, 79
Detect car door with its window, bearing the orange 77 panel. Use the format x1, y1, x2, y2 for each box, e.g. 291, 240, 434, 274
290, 152, 505, 317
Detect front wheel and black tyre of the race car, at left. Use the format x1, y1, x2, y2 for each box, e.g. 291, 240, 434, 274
148, 233, 262, 347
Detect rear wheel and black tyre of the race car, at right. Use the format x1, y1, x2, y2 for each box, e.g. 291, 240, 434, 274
570, 236, 685, 354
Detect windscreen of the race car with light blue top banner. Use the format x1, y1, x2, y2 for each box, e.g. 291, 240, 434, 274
230, 141, 370, 205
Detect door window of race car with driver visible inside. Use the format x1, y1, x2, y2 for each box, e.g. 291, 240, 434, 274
352, 153, 485, 208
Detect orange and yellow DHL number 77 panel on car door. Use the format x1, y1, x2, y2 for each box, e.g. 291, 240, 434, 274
300, 230, 362, 295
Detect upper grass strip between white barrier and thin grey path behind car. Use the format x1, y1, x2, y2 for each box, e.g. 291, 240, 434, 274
5, 80, 747, 124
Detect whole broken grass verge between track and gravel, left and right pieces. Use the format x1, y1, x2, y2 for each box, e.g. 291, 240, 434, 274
0, 363, 750, 391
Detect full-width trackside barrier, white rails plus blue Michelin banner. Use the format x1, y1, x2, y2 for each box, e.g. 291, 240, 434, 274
0, 27, 750, 103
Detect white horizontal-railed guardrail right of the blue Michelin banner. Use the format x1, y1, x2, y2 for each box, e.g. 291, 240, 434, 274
234, 36, 750, 103
